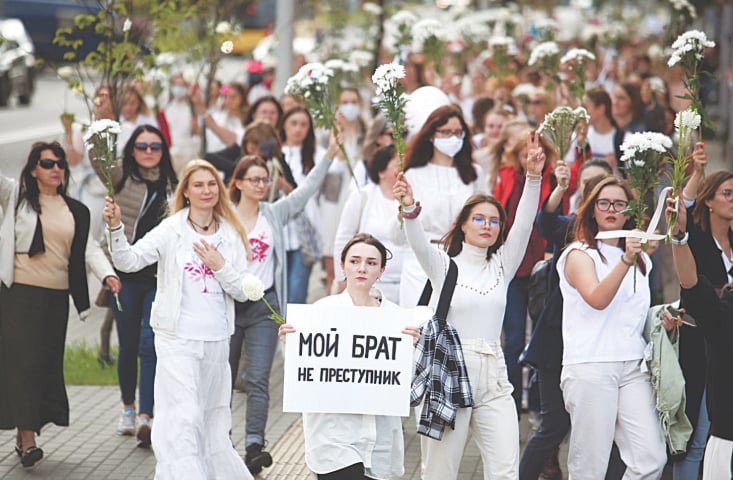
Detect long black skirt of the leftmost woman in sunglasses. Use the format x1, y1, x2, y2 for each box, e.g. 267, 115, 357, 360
0, 283, 69, 434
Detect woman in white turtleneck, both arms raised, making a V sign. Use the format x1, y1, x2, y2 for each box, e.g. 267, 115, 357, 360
394, 134, 545, 480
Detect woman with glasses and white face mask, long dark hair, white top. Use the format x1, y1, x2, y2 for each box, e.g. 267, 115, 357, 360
400, 105, 486, 307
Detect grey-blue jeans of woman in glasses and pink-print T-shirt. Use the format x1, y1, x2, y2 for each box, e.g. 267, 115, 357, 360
229, 289, 279, 447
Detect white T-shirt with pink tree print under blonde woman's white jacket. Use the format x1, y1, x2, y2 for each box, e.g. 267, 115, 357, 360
177, 226, 229, 341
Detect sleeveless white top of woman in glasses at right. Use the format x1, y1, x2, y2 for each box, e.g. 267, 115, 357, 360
557, 242, 652, 365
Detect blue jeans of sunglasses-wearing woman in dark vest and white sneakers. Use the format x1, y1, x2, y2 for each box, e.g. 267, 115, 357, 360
110, 280, 157, 417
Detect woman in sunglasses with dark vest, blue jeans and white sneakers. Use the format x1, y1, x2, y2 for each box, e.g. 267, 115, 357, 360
92, 125, 178, 447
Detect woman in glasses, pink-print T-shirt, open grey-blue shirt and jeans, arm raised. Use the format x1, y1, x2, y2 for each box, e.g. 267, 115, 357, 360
229, 136, 338, 474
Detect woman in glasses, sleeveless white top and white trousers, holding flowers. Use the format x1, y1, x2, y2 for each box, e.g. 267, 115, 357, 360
557, 177, 667, 479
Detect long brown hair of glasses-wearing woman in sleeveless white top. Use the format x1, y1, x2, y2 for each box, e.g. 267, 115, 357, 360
575, 175, 646, 275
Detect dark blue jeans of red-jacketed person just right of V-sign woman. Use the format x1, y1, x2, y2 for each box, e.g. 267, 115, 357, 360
503, 277, 529, 414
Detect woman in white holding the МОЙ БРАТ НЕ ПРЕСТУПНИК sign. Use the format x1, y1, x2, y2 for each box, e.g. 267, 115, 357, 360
279, 233, 420, 480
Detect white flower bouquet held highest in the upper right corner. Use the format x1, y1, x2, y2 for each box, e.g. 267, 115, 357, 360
667, 30, 715, 176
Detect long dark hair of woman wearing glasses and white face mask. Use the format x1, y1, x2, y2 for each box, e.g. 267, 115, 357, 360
405, 105, 478, 185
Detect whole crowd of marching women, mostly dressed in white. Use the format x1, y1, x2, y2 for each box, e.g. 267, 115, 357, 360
0, 7, 733, 480
